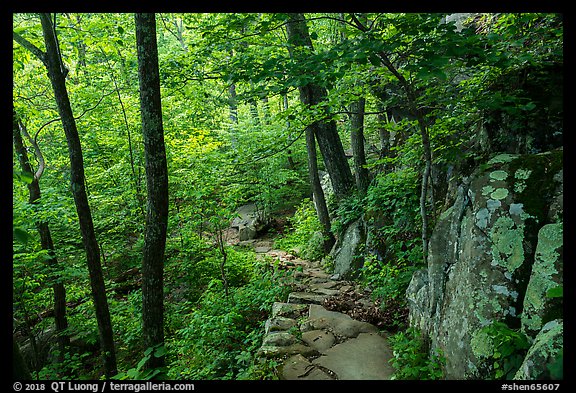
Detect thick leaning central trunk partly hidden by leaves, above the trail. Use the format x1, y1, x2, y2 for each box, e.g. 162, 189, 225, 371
286, 13, 354, 199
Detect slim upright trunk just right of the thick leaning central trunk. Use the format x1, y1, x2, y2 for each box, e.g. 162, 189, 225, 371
350, 98, 370, 195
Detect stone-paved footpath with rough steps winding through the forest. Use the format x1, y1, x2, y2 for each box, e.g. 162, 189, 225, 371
238, 239, 394, 380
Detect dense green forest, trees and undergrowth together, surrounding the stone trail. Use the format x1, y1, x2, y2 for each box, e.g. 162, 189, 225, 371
12, 13, 563, 379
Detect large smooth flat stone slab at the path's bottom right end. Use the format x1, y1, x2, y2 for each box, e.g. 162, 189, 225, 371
312, 333, 394, 380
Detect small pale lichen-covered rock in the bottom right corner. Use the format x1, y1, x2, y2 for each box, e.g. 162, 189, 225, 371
514, 319, 564, 380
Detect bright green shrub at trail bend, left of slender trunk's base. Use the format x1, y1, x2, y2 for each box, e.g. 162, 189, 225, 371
275, 199, 324, 261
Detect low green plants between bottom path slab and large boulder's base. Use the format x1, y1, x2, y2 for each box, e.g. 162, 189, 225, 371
389, 328, 445, 380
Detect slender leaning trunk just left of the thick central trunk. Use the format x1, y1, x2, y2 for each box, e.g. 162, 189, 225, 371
306, 128, 336, 252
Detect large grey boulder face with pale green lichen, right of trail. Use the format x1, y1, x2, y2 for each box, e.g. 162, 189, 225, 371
407, 150, 563, 379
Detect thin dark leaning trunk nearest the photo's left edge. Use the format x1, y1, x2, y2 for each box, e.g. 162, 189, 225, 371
12, 109, 70, 361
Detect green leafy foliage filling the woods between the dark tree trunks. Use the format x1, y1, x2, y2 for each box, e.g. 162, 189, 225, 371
12, 13, 563, 379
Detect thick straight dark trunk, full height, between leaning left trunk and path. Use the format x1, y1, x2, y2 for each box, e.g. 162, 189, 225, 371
134, 14, 168, 369
